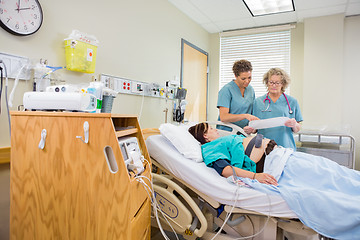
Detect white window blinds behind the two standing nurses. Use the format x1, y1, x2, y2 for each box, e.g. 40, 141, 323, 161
219, 30, 291, 97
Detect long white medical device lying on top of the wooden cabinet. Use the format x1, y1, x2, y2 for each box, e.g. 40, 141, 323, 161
23, 92, 97, 112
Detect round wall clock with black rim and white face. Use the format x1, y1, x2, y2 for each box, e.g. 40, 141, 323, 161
0, 0, 43, 36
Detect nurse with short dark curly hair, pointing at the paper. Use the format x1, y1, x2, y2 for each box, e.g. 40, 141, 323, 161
217, 60, 258, 131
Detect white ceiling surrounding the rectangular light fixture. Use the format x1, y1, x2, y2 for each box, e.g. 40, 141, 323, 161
168, 0, 360, 33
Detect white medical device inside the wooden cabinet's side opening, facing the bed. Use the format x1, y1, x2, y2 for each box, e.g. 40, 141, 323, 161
119, 137, 144, 174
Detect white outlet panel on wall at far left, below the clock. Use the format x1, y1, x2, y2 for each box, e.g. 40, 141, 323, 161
0, 53, 31, 80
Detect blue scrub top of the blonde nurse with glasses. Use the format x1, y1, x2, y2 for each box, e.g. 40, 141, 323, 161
253, 94, 303, 150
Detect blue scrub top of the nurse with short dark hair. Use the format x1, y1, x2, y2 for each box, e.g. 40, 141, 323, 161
217, 80, 255, 128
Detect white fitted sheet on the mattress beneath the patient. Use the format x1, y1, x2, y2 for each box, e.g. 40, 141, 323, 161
146, 135, 297, 218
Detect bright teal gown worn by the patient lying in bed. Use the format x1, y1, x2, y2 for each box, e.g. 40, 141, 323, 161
201, 135, 256, 172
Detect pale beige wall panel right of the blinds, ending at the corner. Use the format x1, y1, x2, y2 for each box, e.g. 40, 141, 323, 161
302, 15, 344, 129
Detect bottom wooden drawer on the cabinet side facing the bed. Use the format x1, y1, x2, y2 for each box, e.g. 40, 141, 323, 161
131, 200, 151, 240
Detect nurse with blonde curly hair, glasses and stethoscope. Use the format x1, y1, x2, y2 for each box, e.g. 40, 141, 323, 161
250, 68, 303, 150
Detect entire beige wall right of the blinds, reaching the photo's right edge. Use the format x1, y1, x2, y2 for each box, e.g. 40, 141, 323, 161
302, 15, 360, 169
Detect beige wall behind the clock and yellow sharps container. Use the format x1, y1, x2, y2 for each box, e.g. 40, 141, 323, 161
0, 0, 210, 147
